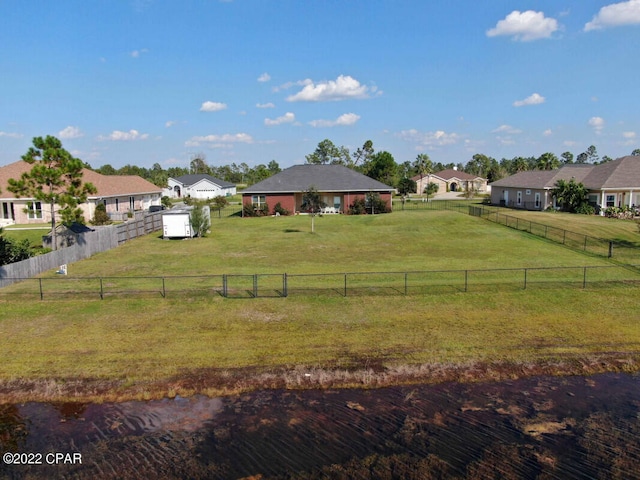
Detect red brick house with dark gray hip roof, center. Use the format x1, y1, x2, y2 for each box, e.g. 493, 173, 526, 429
242, 164, 394, 213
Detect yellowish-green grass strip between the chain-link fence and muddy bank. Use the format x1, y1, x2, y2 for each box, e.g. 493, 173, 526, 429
0, 287, 640, 392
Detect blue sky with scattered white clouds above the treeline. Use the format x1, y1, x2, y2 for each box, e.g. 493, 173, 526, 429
0, 0, 640, 168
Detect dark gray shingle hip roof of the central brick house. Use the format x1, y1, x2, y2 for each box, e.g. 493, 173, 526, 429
243, 164, 393, 193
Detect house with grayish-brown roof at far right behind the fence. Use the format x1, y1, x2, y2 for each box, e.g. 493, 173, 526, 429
491, 155, 640, 211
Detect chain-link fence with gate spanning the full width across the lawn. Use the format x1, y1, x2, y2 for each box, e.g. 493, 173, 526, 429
0, 265, 640, 299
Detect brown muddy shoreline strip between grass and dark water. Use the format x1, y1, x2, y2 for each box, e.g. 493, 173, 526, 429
0, 352, 640, 404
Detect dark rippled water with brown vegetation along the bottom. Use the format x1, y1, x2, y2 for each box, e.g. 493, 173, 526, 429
0, 374, 640, 479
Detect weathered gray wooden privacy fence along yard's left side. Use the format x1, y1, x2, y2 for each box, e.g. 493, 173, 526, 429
0, 213, 162, 287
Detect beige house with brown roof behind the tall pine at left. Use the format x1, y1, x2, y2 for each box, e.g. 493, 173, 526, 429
0, 160, 162, 225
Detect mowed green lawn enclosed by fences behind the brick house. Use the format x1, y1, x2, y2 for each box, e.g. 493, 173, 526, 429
32, 211, 628, 277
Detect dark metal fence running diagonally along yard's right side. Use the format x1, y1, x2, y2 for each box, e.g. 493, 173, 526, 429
469, 205, 640, 264
